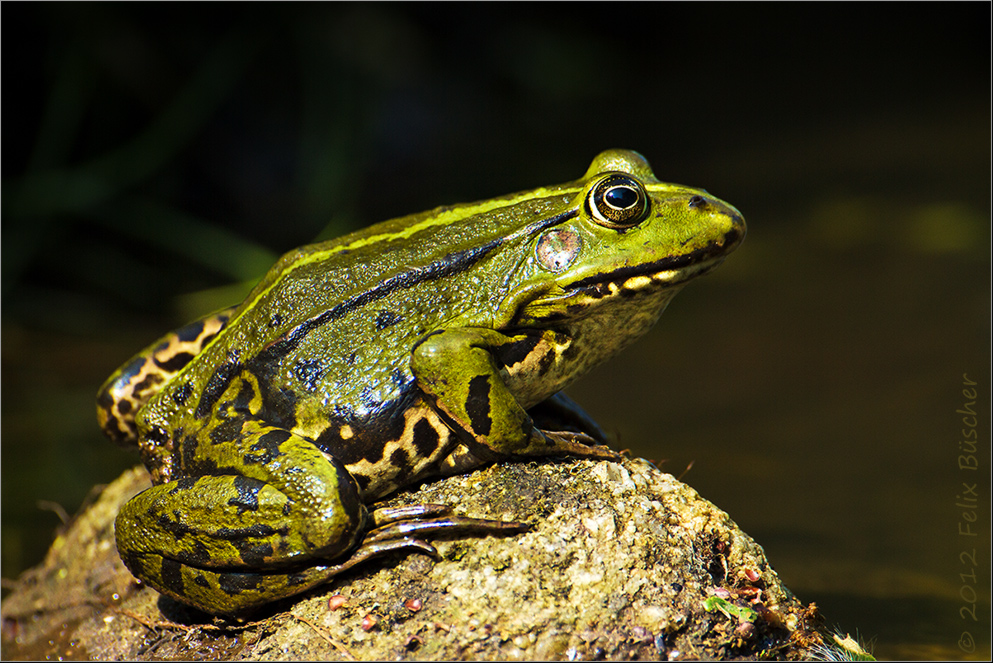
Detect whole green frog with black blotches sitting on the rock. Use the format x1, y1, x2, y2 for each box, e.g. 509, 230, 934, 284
97, 149, 746, 617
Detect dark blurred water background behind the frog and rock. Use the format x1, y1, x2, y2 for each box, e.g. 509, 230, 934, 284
0, 3, 991, 659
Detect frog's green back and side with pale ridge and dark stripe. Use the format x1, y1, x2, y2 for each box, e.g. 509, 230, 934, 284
136, 191, 574, 474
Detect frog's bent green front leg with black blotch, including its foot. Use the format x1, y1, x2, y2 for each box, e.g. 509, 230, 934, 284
411, 327, 618, 462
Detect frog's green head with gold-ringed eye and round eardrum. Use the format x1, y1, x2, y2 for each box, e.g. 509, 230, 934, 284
512, 150, 745, 325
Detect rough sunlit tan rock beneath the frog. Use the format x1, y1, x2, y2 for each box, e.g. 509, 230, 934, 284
2, 459, 844, 660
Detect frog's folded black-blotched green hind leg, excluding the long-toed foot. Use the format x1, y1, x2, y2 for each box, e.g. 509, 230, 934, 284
116, 417, 367, 614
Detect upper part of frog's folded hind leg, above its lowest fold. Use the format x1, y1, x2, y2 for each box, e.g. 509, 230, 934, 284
117, 428, 365, 569
